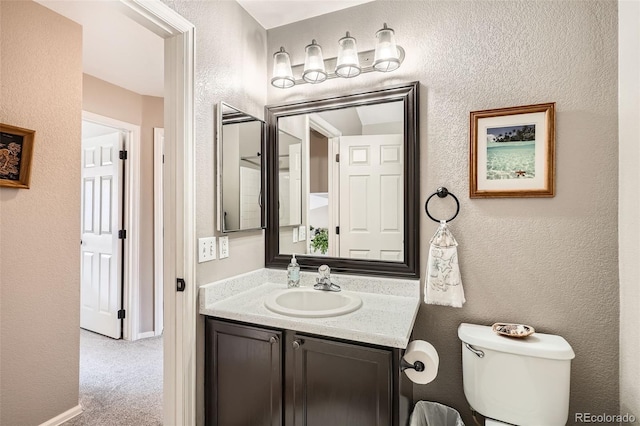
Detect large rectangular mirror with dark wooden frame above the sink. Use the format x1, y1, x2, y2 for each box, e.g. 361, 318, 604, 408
265, 82, 419, 278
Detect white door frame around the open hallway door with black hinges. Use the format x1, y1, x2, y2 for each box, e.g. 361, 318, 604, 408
82, 110, 140, 340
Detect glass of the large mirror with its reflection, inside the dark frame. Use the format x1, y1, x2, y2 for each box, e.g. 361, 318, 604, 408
278, 101, 404, 262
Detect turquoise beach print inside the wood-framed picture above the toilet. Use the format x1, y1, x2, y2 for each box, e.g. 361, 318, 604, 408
487, 124, 536, 180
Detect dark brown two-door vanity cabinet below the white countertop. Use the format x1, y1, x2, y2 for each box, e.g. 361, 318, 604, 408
205, 317, 412, 426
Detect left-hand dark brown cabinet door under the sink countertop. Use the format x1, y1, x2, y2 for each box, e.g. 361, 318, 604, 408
205, 318, 282, 426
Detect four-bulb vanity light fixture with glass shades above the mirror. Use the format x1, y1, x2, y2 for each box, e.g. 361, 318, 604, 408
271, 23, 405, 89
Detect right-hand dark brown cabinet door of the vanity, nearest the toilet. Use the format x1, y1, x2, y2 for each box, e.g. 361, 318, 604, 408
285, 333, 393, 426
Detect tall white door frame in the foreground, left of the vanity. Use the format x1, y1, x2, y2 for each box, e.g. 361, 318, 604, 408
117, 0, 197, 425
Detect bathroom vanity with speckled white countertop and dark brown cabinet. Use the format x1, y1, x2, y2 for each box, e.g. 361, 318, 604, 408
200, 269, 420, 426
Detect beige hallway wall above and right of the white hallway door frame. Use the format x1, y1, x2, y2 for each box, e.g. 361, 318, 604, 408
82, 74, 164, 333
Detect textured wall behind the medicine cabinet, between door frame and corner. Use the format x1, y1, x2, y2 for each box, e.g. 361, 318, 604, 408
163, 0, 267, 424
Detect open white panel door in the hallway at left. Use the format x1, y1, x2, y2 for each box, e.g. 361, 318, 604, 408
80, 132, 122, 339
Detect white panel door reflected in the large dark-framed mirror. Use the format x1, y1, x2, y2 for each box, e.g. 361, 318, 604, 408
339, 135, 404, 262
